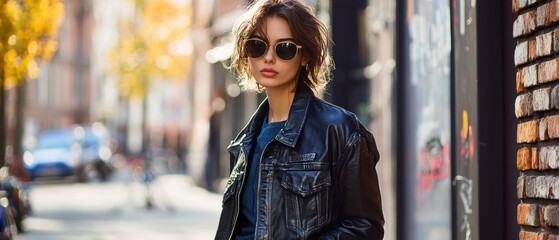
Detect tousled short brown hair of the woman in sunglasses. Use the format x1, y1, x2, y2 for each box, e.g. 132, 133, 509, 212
226, 0, 333, 92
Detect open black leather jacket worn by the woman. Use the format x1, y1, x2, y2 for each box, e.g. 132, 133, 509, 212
215, 86, 384, 240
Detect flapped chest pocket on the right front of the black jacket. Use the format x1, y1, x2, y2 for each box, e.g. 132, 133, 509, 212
281, 163, 331, 232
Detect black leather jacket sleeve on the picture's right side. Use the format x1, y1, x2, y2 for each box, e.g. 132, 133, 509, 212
320, 130, 384, 240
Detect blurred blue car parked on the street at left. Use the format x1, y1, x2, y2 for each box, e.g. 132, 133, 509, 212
23, 129, 81, 180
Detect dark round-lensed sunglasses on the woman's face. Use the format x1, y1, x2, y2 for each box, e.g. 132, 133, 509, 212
245, 38, 303, 61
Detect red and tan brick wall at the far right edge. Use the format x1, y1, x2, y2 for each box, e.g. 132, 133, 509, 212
512, 0, 559, 240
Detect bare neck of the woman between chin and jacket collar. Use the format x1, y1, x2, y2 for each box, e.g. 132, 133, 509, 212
266, 88, 295, 123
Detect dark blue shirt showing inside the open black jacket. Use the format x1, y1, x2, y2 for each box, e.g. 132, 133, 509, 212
235, 118, 285, 240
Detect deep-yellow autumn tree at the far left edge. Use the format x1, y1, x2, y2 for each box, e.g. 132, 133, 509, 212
0, 0, 64, 166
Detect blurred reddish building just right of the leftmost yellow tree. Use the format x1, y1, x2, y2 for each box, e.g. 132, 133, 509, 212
25, 0, 94, 132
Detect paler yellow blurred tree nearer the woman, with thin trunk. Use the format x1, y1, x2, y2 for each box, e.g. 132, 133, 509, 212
109, 0, 192, 154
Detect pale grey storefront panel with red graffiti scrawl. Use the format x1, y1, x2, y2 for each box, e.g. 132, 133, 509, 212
399, 0, 452, 240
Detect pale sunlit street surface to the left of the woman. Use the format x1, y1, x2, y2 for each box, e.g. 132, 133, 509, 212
15, 172, 221, 240
